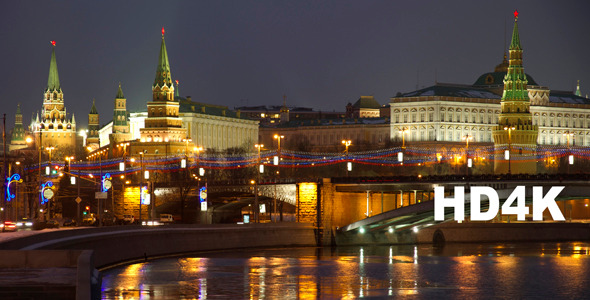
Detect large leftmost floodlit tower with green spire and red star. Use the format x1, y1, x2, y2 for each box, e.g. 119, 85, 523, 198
29, 41, 76, 159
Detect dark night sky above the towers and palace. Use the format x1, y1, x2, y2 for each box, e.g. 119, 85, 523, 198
0, 0, 590, 130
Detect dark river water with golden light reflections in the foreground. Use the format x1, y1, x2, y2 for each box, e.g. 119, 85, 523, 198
102, 243, 590, 299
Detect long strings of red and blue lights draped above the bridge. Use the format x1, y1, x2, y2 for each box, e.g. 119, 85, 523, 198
19, 144, 590, 177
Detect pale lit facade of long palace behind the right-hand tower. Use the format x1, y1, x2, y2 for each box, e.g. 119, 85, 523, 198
391, 100, 590, 146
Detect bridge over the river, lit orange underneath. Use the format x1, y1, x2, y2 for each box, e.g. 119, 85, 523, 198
205, 174, 590, 245
